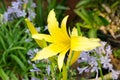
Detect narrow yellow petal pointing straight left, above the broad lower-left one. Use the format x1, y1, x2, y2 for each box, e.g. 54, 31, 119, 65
32, 34, 52, 42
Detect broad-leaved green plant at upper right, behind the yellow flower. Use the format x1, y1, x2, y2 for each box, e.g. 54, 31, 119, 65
74, 0, 112, 37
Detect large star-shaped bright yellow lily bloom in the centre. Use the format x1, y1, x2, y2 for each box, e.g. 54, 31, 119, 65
25, 10, 100, 70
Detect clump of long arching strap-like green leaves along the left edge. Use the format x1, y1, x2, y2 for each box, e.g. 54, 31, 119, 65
0, 18, 33, 80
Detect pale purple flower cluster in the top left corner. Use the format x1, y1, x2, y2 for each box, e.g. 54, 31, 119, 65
4, 0, 36, 23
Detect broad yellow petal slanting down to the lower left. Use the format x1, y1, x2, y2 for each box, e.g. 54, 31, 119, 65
32, 44, 62, 61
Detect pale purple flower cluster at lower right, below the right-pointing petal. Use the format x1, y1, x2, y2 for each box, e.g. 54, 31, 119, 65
77, 42, 120, 80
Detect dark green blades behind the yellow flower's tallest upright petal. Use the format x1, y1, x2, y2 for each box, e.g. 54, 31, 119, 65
35, 0, 69, 32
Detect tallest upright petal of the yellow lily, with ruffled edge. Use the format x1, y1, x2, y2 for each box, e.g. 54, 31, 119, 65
47, 10, 69, 44
